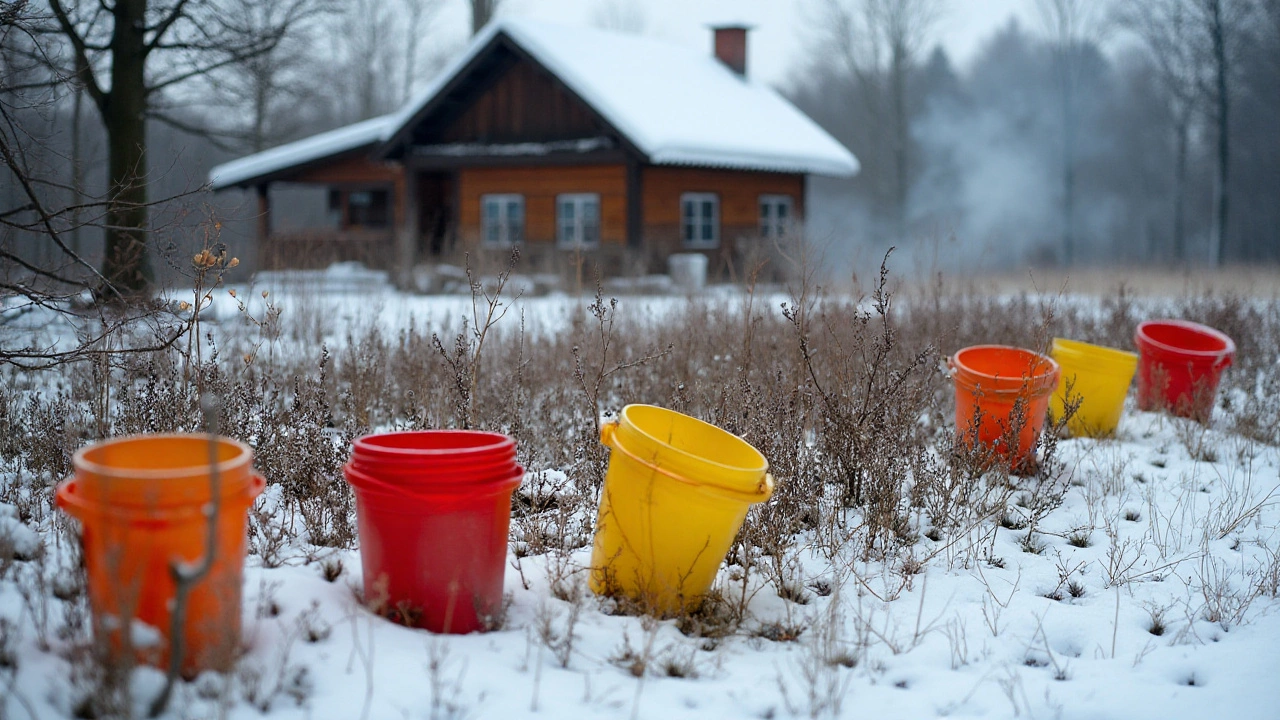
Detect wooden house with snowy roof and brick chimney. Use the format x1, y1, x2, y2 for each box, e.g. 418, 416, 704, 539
210, 19, 858, 280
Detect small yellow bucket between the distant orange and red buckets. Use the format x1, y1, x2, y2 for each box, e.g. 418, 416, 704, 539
1050, 337, 1138, 437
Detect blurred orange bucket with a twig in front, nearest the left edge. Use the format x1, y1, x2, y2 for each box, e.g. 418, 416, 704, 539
56, 434, 266, 676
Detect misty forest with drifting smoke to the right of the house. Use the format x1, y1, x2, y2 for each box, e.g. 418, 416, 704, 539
786, 0, 1280, 270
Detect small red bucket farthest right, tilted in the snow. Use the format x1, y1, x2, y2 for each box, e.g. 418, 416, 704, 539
1133, 320, 1235, 420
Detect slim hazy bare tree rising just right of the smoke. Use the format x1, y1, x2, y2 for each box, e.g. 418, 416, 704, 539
1037, 0, 1102, 266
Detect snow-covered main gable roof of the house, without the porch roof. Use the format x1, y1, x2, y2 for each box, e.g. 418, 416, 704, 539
385, 18, 859, 177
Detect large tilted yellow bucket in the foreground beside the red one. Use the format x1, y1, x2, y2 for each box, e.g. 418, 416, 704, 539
590, 405, 773, 615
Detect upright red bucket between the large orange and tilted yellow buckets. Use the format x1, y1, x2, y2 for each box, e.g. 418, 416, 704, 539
343, 430, 524, 633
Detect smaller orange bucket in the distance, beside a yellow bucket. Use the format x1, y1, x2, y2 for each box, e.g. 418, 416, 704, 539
947, 345, 1061, 468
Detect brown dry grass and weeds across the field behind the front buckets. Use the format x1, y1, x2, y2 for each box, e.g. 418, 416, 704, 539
0, 251, 1280, 710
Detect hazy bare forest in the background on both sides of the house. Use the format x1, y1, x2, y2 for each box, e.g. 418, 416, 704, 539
0, 0, 1280, 285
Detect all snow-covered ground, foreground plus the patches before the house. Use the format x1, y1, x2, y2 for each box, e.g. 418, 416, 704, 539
0, 279, 1280, 720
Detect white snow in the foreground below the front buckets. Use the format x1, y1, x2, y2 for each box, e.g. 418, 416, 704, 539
10, 399, 1280, 720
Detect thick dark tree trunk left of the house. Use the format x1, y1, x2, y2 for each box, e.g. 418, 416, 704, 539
102, 0, 154, 297
